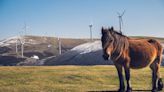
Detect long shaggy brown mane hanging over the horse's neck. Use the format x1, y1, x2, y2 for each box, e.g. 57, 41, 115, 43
108, 28, 129, 60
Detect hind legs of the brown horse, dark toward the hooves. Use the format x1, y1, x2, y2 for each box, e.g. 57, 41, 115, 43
150, 57, 162, 92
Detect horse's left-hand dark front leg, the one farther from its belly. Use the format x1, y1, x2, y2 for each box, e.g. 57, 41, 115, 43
115, 64, 125, 92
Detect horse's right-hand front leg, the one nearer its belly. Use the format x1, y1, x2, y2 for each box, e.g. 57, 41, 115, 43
124, 64, 132, 92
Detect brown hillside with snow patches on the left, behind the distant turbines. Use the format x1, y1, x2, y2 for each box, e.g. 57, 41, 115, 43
0, 36, 89, 66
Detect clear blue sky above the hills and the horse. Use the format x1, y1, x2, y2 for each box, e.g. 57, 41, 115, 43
0, 0, 164, 39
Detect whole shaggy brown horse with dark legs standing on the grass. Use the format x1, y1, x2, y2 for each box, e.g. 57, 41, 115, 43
101, 27, 163, 92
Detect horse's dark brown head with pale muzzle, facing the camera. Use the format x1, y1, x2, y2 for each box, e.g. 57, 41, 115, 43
101, 27, 114, 60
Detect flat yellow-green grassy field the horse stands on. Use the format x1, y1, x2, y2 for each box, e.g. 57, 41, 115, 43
0, 66, 164, 92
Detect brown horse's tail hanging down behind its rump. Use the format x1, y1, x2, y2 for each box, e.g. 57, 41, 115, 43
148, 39, 163, 64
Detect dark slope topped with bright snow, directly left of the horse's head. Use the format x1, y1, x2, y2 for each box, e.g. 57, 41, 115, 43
45, 41, 112, 65
